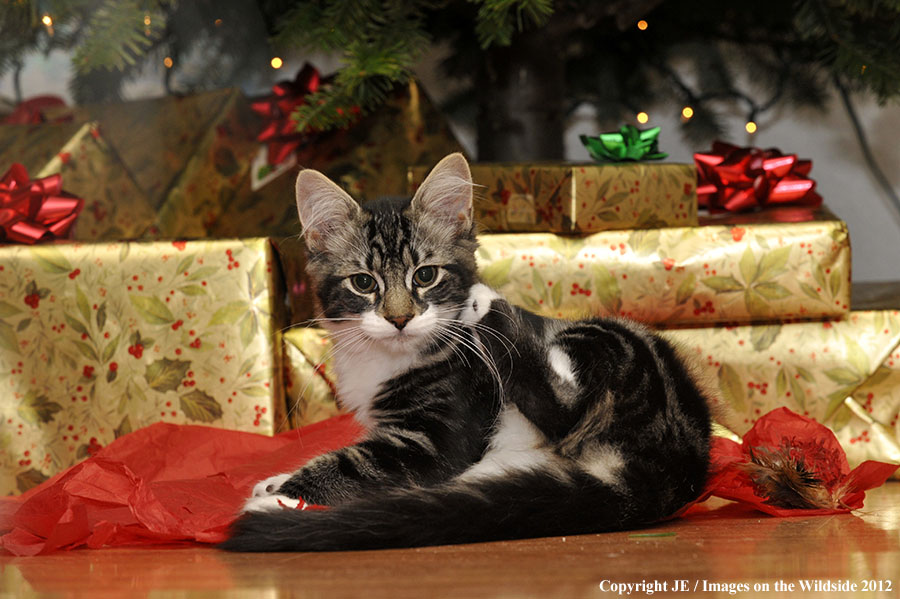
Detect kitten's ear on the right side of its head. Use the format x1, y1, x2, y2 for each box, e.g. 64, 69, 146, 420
411, 152, 473, 234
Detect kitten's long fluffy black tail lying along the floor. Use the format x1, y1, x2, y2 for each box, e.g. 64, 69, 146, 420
220, 471, 680, 551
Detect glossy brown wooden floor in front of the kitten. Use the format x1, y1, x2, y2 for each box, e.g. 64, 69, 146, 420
0, 482, 900, 599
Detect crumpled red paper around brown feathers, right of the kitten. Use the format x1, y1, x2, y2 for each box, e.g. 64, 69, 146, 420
700, 408, 900, 517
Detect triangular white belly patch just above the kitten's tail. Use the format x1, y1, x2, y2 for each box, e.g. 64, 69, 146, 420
459, 406, 555, 480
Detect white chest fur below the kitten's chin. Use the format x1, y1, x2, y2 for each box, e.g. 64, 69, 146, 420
334, 349, 416, 428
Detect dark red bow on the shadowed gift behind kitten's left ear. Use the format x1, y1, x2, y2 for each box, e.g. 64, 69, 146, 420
251, 63, 320, 166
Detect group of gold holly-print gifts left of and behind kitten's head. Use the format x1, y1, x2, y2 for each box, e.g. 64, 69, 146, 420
0, 83, 460, 495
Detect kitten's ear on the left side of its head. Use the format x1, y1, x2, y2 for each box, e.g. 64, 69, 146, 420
296, 169, 359, 251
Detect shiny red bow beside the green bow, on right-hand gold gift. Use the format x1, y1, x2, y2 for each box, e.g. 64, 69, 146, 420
694, 141, 822, 212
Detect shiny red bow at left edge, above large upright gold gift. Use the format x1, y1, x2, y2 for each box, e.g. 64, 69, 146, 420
0, 163, 84, 245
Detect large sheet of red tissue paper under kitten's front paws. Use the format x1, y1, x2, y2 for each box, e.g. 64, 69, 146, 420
0, 416, 362, 555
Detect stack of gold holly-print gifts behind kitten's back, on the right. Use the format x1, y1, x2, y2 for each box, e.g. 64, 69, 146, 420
285, 163, 900, 478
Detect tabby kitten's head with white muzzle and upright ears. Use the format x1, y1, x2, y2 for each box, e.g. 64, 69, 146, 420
297, 154, 477, 351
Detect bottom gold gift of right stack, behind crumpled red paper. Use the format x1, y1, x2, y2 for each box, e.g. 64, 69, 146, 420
662, 310, 900, 476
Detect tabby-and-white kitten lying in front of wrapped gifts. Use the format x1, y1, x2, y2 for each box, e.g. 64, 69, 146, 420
223, 154, 710, 551
